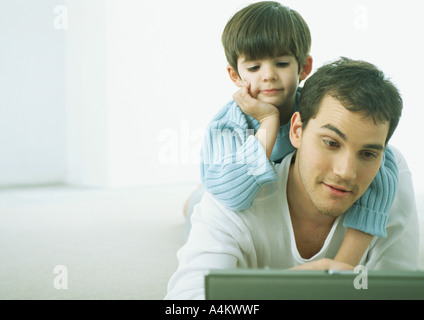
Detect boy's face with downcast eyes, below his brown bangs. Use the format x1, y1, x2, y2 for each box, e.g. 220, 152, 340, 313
228, 55, 310, 109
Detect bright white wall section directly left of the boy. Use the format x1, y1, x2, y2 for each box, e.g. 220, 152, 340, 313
103, 0, 233, 185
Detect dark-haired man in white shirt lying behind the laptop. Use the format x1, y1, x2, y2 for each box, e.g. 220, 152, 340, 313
166, 58, 419, 299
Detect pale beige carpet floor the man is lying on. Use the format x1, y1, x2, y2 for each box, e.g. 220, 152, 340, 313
0, 185, 424, 299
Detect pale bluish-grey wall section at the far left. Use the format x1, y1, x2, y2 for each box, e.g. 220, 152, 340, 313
0, 0, 66, 186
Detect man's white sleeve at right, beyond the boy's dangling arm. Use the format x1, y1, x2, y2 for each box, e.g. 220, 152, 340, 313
366, 146, 419, 270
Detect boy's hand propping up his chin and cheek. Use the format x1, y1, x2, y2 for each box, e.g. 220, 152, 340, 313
233, 81, 280, 123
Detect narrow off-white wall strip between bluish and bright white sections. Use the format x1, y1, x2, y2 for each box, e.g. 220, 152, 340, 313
65, 0, 110, 186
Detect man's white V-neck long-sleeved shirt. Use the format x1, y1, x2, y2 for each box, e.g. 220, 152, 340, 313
165, 146, 419, 299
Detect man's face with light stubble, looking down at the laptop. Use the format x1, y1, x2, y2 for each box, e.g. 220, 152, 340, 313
291, 95, 389, 217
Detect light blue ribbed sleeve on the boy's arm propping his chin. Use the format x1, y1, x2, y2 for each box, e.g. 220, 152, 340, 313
201, 104, 277, 211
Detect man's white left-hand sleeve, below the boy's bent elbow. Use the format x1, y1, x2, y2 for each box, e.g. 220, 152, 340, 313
165, 193, 254, 300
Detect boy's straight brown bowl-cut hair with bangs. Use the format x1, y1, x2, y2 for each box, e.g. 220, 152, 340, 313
222, 1, 311, 72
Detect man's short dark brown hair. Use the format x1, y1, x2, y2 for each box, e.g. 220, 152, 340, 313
299, 57, 403, 145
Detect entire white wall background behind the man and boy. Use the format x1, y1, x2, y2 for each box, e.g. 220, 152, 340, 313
0, 0, 424, 192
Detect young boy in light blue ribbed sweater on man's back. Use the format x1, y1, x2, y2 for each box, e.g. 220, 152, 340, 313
188, 1, 398, 266
